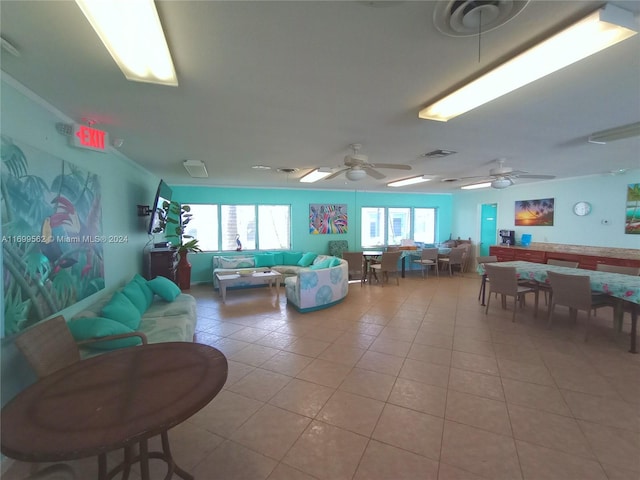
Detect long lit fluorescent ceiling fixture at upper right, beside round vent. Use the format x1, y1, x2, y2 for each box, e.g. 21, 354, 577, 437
418, 5, 638, 122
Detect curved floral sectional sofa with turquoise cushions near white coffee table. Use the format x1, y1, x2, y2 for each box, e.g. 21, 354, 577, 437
213, 255, 349, 313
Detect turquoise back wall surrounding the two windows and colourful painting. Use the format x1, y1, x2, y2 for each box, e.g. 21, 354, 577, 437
171, 185, 453, 283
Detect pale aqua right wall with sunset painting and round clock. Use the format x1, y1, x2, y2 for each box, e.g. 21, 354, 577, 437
452, 171, 640, 248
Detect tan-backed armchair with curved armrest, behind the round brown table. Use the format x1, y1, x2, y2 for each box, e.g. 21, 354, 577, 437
15, 315, 147, 378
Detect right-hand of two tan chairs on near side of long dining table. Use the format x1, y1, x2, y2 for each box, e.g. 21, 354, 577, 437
547, 270, 611, 342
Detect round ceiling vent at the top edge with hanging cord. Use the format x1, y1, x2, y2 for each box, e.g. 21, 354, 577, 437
433, 0, 529, 37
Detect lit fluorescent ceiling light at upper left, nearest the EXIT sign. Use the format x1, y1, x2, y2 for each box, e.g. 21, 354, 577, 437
76, 0, 178, 86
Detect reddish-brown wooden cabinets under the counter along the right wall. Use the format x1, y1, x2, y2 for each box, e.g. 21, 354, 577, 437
489, 245, 640, 270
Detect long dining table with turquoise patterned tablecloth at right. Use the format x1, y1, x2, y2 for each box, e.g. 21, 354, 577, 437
477, 260, 640, 353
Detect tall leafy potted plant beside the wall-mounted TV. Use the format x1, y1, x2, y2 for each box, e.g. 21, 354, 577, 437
163, 201, 202, 290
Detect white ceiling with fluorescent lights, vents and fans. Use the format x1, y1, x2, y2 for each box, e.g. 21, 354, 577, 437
0, 0, 640, 193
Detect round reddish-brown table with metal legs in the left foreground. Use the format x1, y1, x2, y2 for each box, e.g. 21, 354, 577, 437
0, 342, 228, 480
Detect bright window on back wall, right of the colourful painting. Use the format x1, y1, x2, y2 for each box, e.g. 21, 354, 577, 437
360, 207, 436, 248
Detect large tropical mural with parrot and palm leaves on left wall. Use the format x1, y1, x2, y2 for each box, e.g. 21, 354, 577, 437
0, 136, 104, 335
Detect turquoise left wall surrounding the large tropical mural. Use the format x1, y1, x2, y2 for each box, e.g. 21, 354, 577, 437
0, 73, 160, 404
